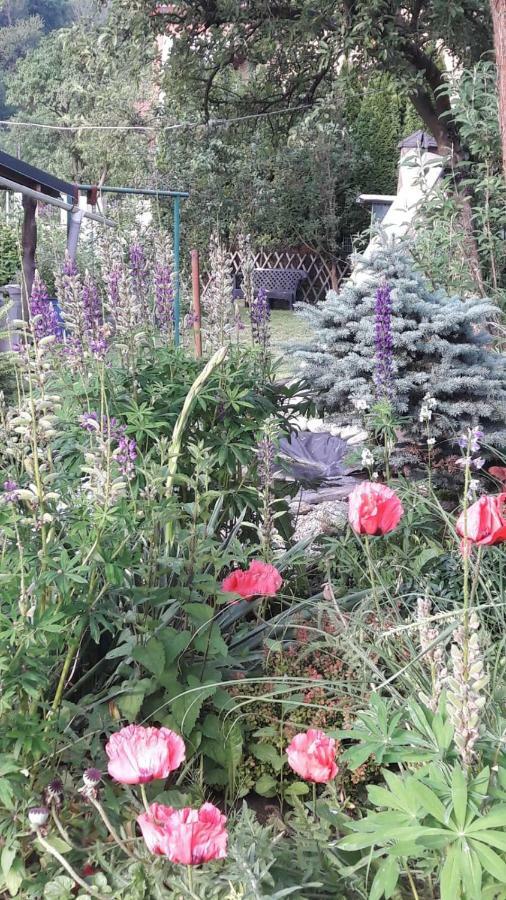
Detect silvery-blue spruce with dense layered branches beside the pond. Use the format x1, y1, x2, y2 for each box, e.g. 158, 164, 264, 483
295, 241, 506, 446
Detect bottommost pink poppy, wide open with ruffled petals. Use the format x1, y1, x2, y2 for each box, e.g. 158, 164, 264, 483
137, 803, 228, 866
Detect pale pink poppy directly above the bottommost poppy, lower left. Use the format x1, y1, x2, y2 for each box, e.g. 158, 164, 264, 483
105, 725, 185, 784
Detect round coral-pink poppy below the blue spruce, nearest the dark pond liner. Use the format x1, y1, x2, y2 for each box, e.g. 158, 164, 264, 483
348, 481, 404, 535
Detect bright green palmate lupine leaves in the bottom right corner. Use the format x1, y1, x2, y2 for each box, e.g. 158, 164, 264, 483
338, 700, 506, 900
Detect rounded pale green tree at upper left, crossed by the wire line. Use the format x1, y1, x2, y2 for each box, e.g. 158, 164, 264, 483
4, 8, 153, 184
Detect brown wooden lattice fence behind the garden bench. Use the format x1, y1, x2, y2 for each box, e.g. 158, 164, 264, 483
202, 247, 349, 303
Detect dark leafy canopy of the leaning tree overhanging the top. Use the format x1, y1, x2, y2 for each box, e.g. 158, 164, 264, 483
130, 0, 492, 151
